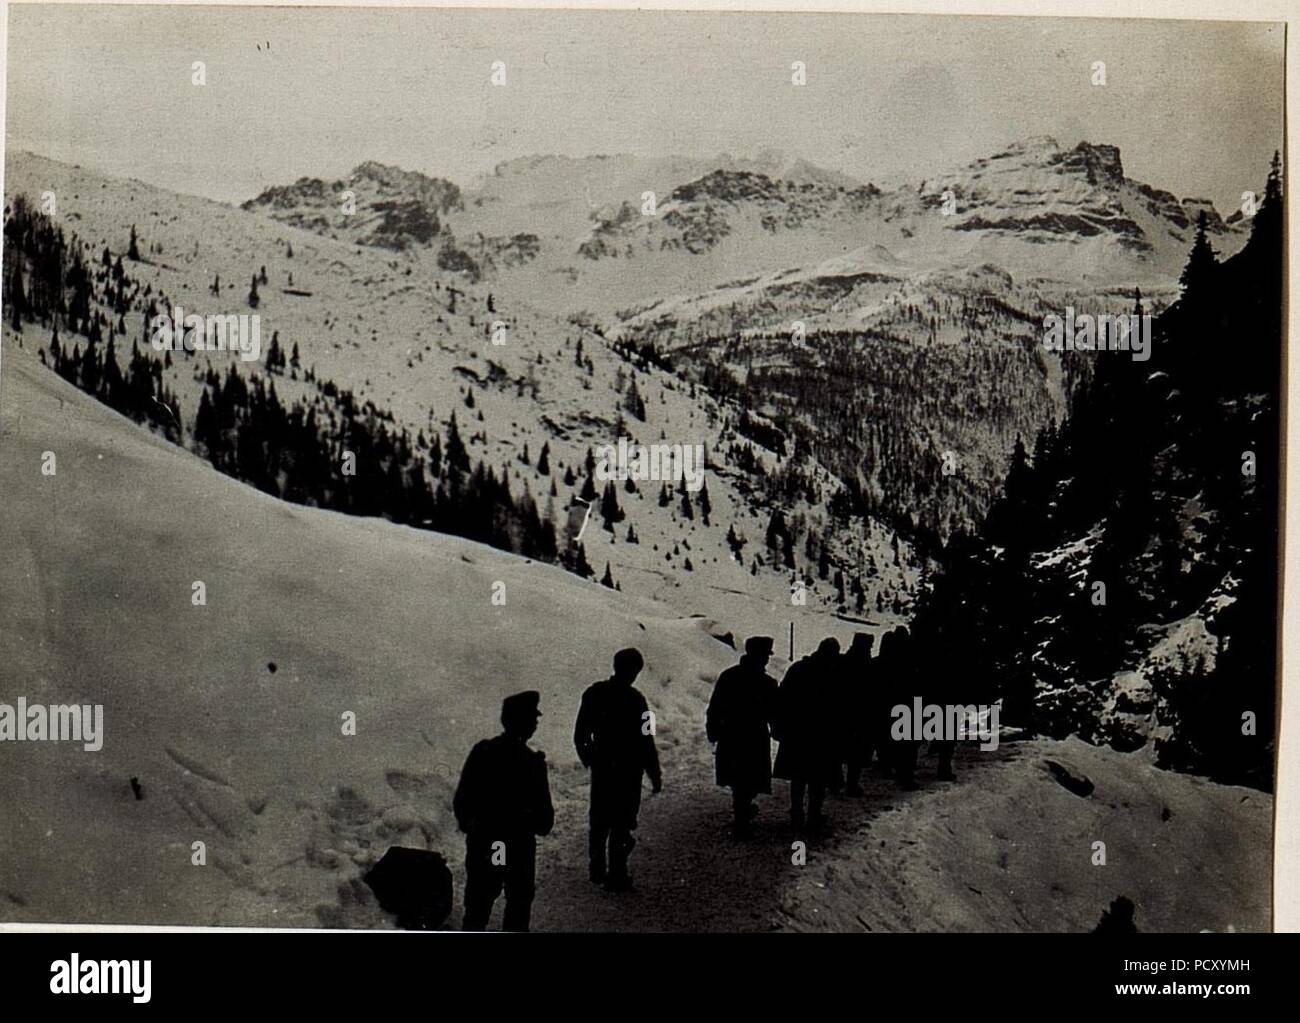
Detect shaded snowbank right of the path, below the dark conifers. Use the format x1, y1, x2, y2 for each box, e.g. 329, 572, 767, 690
783, 738, 1273, 932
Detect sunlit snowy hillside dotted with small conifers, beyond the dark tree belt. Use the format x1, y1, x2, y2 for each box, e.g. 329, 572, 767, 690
5, 153, 918, 628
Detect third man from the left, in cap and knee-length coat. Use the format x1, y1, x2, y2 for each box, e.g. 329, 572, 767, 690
705, 636, 777, 835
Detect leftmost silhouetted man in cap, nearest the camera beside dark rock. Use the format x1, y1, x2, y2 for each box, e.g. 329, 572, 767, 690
452, 692, 555, 931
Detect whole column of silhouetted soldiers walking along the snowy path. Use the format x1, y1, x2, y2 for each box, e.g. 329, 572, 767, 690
452, 627, 956, 931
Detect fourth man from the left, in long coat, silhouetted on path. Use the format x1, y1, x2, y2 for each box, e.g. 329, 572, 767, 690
772, 638, 840, 829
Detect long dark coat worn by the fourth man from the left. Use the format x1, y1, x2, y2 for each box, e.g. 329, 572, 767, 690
772, 654, 840, 784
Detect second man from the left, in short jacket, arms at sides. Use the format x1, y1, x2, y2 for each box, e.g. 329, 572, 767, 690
573, 647, 663, 892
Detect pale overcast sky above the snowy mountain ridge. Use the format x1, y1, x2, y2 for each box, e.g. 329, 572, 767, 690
7, 6, 1283, 212
